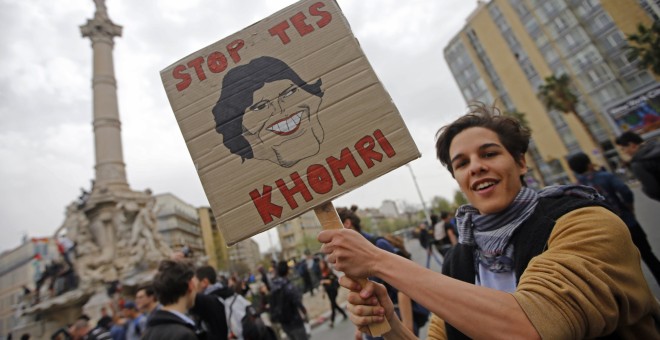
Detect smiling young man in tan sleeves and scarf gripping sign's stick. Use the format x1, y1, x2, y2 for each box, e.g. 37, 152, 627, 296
318, 105, 660, 339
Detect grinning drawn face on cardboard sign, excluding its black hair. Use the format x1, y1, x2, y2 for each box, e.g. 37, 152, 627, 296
243, 79, 323, 167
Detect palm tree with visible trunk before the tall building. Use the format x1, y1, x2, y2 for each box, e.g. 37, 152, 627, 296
539, 74, 604, 155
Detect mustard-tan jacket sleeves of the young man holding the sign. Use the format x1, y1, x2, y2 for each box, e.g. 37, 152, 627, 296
428, 207, 660, 339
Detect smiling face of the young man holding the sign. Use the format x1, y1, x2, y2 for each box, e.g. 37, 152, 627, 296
449, 127, 527, 214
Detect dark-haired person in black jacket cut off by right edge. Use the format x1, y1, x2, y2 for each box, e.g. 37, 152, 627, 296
616, 131, 660, 201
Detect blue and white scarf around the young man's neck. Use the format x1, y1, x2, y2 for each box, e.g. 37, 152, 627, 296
456, 185, 604, 273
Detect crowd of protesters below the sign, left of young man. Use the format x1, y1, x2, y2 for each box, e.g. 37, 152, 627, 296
32, 247, 346, 340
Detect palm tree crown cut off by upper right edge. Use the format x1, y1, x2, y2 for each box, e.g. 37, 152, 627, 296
625, 20, 660, 76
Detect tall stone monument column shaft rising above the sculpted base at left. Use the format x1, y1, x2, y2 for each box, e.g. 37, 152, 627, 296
80, 0, 130, 193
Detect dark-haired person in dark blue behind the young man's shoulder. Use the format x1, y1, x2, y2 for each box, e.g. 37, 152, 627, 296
568, 152, 660, 283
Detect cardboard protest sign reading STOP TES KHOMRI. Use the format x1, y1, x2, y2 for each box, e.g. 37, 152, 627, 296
161, 0, 420, 245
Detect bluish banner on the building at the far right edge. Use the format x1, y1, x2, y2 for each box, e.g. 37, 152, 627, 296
606, 84, 660, 134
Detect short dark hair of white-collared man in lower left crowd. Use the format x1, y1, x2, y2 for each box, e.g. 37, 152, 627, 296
153, 260, 195, 306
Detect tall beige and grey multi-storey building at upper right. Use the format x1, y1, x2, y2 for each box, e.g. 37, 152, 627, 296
444, 0, 658, 185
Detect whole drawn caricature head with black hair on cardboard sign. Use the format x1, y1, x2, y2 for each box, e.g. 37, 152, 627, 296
213, 57, 324, 168
